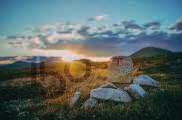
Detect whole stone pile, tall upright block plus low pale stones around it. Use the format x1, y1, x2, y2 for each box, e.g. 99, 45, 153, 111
70, 56, 159, 107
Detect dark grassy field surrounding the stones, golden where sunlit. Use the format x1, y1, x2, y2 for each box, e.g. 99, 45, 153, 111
0, 54, 182, 120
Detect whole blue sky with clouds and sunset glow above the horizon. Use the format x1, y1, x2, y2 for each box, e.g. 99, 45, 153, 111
0, 0, 182, 60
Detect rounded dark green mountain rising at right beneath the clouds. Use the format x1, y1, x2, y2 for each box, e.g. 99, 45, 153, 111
131, 47, 173, 58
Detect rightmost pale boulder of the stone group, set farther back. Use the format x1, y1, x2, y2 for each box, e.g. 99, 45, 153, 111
133, 75, 159, 87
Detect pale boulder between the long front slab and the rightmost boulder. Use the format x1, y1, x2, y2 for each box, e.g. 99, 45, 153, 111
125, 84, 146, 99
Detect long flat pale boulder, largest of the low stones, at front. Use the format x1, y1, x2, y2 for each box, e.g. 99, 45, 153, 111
90, 88, 131, 102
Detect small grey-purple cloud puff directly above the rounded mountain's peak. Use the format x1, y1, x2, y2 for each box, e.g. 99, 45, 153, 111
144, 21, 161, 30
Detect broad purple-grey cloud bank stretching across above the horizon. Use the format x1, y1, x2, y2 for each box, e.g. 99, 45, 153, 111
0, 14, 182, 57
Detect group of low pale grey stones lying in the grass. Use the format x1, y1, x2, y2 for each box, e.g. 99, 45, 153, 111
70, 75, 159, 107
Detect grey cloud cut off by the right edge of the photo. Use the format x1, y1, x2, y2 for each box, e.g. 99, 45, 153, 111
168, 18, 182, 31
